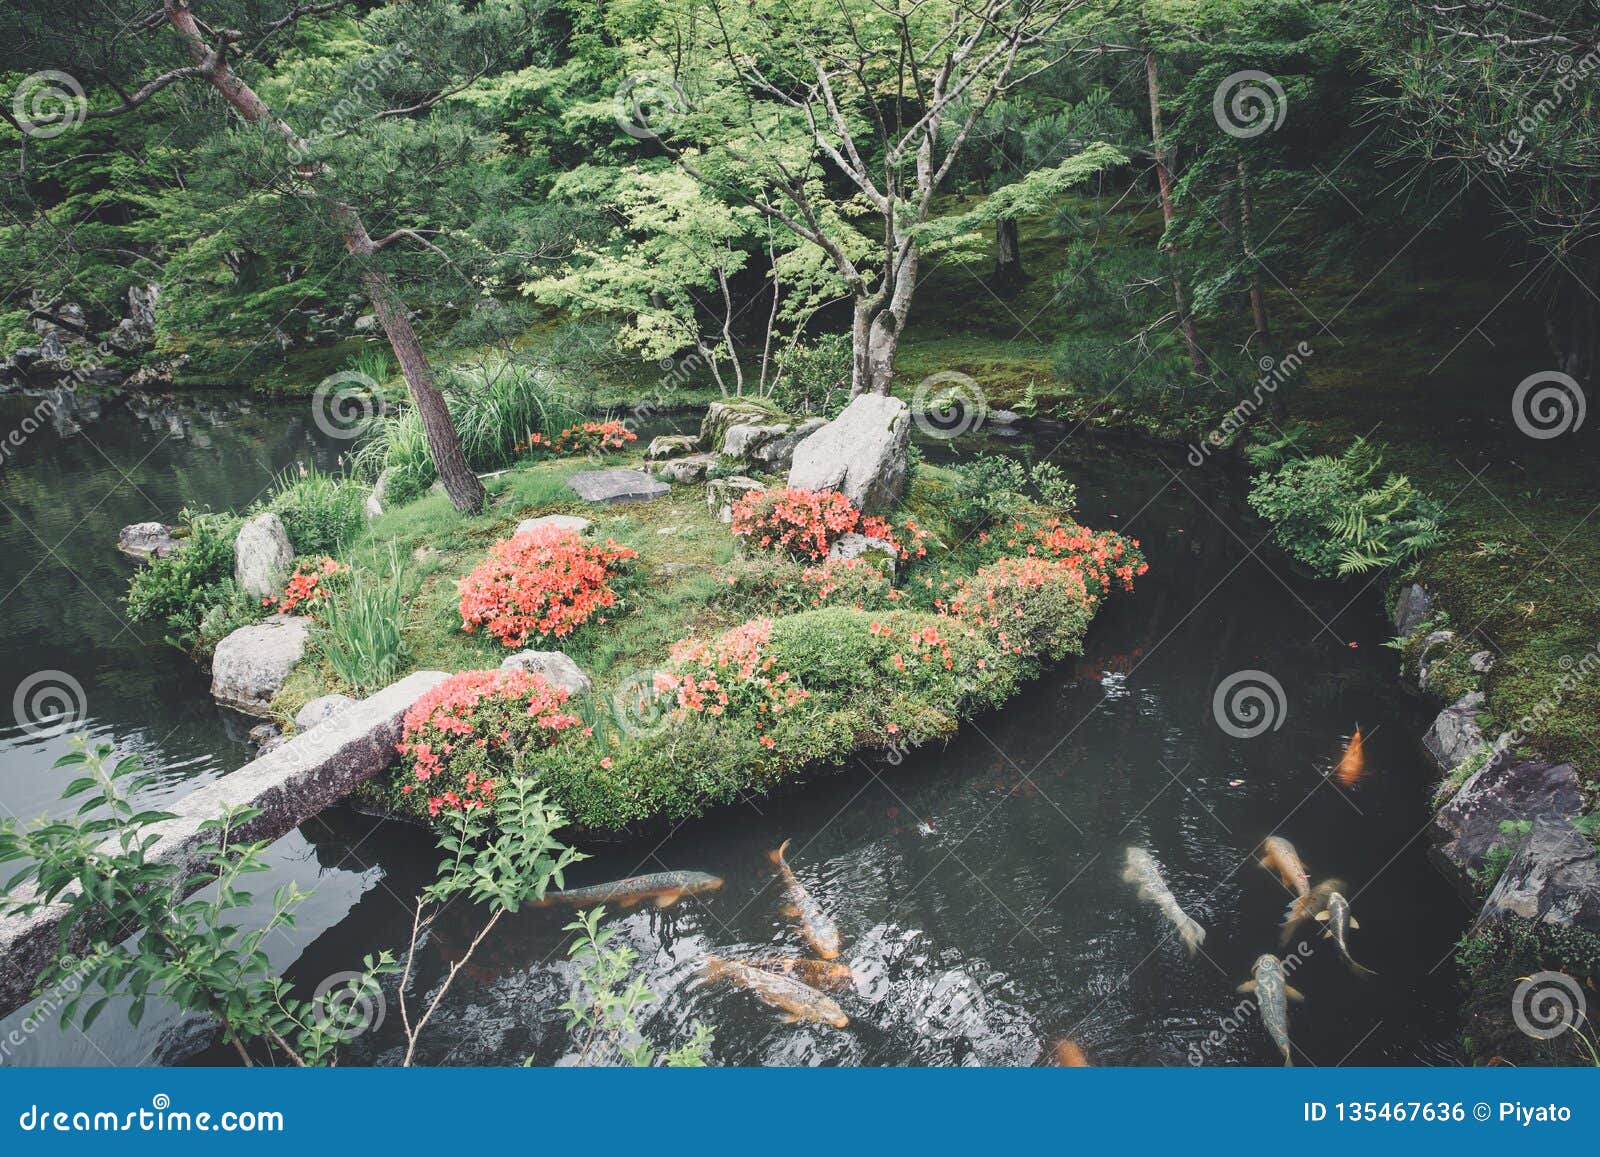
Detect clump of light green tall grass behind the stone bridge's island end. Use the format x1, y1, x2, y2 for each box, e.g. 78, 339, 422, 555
312, 539, 413, 695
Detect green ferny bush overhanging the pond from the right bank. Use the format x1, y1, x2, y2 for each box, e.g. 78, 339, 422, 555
1250, 438, 1443, 578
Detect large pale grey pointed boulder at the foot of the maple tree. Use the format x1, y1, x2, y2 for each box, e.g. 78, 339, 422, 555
789, 394, 910, 514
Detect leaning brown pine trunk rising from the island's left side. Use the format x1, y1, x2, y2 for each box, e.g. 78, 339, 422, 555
165, 0, 483, 514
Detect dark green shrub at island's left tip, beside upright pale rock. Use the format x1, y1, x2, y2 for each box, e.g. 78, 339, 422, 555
125, 509, 252, 651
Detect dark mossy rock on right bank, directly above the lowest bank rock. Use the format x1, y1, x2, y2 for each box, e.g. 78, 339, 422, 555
1430, 752, 1584, 888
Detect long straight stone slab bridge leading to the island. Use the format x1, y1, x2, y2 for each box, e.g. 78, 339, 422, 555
0, 671, 450, 1016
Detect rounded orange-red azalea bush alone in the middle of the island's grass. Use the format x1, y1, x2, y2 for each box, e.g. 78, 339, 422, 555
456, 526, 638, 647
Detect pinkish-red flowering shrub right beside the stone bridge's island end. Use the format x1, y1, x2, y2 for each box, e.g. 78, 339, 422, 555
397, 671, 589, 816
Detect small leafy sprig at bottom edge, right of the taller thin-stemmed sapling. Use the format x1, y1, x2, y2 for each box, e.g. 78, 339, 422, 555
562, 907, 712, 1069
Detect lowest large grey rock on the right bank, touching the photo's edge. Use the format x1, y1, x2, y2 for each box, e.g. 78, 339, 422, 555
1478, 818, 1600, 933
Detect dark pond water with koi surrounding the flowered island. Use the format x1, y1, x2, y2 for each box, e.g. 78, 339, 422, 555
0, 398, 1467, 1064
